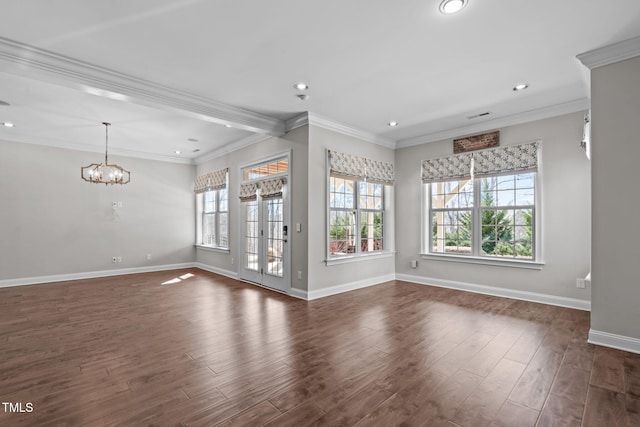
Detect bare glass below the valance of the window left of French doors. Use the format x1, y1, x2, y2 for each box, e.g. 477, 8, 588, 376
201, 188, 229, 248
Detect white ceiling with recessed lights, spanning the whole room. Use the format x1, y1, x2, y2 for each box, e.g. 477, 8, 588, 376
0, 0, 640, 162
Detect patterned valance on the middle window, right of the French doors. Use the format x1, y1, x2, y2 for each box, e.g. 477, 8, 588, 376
328, 151, 394, 185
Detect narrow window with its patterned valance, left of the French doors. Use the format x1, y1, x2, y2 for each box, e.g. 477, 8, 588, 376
194, 169, 229, 250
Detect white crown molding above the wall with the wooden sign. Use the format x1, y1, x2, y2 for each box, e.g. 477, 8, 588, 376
396, 98, 590, 148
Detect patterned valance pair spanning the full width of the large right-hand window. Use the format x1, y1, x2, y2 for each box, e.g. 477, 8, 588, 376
422, 142, 540, 183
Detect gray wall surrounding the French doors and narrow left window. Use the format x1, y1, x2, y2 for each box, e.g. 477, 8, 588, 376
194, 126, 309, 291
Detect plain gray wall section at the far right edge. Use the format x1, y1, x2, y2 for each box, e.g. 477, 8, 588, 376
591, 57, 640, 339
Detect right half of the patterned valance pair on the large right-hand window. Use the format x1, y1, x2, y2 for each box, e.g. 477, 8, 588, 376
473, 142, 539, 177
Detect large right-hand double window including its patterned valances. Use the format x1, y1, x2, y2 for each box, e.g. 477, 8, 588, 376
422, 142, 539, 262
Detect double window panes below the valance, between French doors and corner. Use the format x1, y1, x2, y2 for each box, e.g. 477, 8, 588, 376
329, 177, 384, 257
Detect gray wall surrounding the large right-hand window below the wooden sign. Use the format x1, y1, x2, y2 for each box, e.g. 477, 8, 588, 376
396, 113, 590, 300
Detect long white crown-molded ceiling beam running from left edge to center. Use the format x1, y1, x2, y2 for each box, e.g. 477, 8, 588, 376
0, 37, 285, 136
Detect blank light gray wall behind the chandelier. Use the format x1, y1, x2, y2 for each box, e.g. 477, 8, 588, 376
0, 141, 194, 280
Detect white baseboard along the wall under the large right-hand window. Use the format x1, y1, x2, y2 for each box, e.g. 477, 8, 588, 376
396, 274, 591, 311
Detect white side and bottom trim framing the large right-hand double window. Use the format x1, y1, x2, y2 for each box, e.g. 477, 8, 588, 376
420, 171, 545, 270
